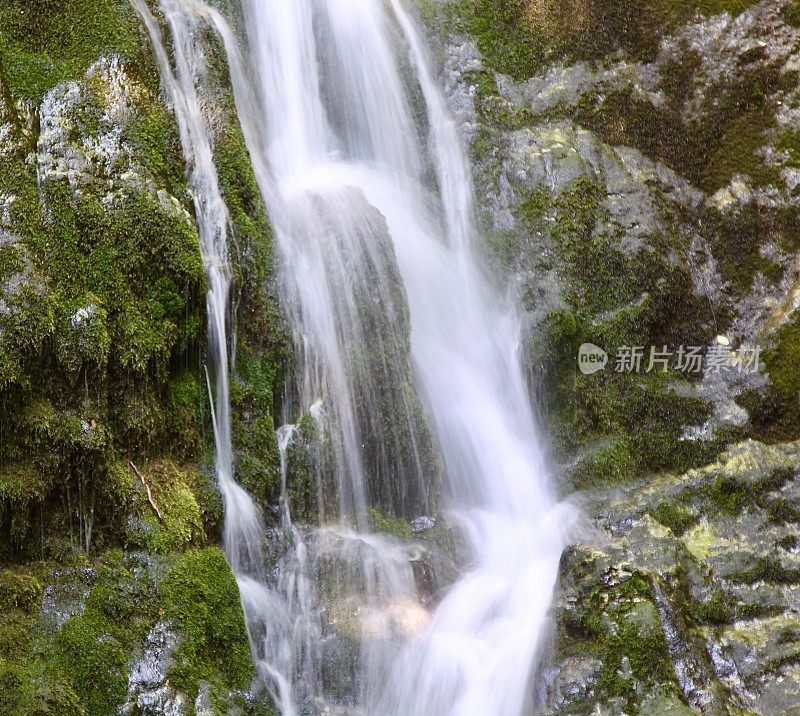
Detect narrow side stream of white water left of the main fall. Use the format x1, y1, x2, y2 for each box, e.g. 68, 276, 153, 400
131, 0, 302, 714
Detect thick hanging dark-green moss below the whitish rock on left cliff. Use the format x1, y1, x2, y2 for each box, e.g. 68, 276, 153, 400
0, 175, 204, 547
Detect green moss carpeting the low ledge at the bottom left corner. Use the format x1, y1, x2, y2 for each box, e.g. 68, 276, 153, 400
0, 547, 256, 716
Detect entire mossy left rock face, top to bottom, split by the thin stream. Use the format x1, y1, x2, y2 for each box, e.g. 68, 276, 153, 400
0, 0, 287, 716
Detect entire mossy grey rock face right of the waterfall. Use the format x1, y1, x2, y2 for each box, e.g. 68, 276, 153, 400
423, 0, 800, 715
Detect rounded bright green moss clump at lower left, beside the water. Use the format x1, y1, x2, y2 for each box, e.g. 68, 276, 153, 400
162, 547, 253, 699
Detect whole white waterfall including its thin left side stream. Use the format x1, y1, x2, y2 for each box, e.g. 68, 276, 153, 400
138, 0, 572, 716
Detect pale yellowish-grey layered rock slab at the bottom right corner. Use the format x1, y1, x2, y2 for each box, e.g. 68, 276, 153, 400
544, 441, 800, 714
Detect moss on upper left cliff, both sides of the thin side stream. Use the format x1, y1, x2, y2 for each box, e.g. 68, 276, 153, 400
0, 0, 289, 559
